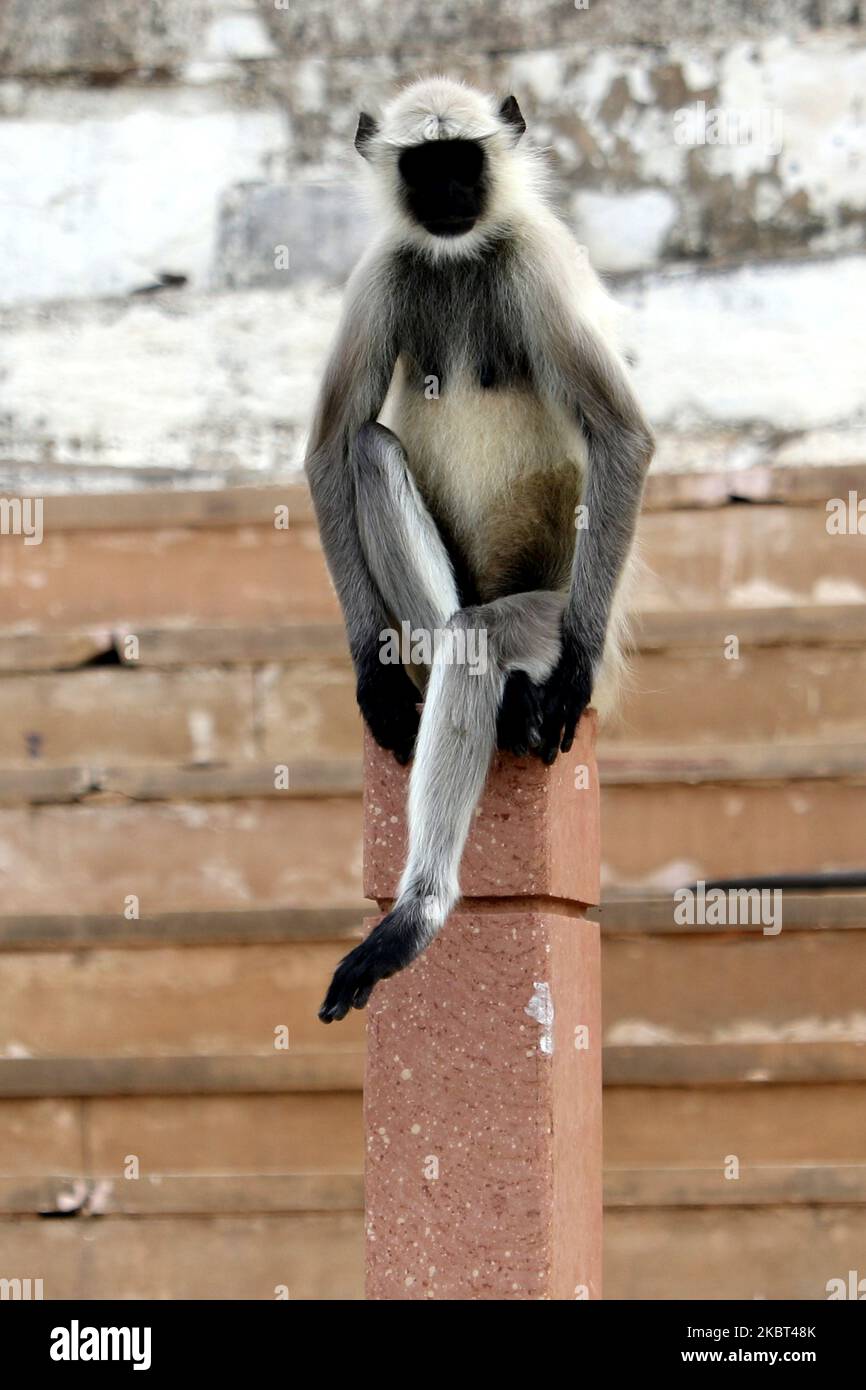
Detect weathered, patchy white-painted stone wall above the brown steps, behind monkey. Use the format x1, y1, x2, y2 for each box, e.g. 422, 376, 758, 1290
0, 0, 866, 488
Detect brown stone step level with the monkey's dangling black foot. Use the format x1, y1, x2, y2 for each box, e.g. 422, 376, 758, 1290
0, 934, 866, 1061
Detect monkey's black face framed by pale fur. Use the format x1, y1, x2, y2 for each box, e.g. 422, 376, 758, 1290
399, 140, 487, 236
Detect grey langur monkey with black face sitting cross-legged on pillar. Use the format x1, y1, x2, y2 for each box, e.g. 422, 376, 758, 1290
306, 78, 653, 1023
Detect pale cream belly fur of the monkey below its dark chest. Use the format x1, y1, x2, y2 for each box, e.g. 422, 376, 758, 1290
382, 363, 587, 580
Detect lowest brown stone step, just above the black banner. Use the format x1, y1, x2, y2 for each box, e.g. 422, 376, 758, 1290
0, 1202, 866, 1301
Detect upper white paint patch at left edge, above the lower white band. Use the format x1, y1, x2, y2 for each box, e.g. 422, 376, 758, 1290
0, 89, 285, 304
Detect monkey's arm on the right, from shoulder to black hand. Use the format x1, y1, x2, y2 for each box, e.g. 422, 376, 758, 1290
541, 290, 653, 762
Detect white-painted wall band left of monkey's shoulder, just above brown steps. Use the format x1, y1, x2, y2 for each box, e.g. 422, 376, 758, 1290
0, 282, 330, 473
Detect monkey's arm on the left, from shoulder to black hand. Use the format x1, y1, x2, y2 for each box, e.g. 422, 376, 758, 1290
306, 264, 418, 762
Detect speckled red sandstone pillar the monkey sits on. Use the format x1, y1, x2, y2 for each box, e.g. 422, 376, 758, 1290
364, 712, 602, 1300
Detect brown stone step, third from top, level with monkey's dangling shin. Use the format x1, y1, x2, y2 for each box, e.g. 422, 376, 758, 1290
0, 774, 865, 916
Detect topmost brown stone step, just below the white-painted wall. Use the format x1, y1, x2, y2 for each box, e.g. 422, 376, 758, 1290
0, 467, 866, 634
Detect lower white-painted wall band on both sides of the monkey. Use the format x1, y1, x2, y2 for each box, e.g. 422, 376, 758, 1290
6, 247, 866, 486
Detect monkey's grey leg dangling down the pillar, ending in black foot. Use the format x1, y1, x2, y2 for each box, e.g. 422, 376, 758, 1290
320, 592, 564, 1023
